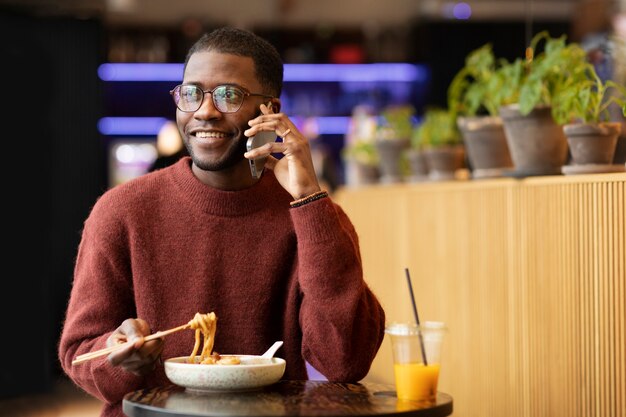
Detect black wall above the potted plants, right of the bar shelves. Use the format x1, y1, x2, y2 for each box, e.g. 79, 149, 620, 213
408, 20, 570, 107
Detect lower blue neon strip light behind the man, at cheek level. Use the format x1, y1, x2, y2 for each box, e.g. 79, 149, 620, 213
98, 117, 350, 136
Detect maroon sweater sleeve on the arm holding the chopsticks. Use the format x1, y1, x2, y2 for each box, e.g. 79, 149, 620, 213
58, 197, 143, 403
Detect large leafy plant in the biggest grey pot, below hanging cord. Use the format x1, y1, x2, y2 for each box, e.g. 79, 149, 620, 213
496, 31, 586, 177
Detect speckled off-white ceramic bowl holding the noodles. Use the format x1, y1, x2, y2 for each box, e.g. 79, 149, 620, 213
163, 355, 286, 391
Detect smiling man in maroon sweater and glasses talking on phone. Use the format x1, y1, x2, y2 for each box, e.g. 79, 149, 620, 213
59, 28, 385, 416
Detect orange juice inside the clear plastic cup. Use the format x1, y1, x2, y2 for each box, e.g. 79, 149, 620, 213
393, 362, 439, 401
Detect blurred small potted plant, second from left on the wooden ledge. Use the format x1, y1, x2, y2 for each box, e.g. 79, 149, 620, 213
374, 105, 415, 183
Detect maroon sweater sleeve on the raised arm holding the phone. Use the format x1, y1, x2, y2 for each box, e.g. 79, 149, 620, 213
290, 198, 385, 382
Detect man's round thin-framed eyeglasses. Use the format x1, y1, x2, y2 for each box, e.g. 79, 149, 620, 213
170, 84, 272, 113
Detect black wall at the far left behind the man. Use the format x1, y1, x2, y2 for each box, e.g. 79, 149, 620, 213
0, 11, 106, 398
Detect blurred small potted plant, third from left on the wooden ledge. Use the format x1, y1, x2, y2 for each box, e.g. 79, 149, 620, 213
414, 107, 465, 181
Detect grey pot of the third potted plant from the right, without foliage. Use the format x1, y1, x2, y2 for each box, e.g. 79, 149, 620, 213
457, 116, 513, 178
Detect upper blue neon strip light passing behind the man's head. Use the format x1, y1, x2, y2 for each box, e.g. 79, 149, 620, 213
98, 63, 428, 82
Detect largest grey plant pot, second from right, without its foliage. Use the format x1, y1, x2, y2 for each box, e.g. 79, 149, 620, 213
500, 105, 567, 177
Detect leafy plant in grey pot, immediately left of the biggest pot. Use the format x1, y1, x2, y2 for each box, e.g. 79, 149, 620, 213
448, 43, 513, 178
